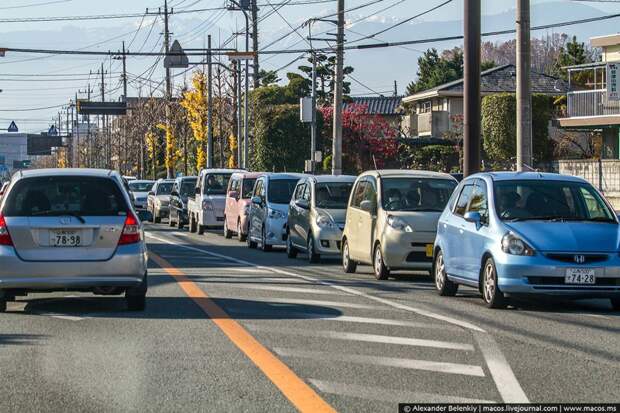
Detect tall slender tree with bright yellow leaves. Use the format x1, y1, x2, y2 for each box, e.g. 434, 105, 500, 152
180, 71, 209, 171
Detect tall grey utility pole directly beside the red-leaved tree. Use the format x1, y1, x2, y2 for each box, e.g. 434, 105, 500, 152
332, 0, 344, 175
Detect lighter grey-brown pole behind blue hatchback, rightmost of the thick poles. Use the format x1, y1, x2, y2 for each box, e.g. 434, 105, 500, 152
517, 0, 533, 172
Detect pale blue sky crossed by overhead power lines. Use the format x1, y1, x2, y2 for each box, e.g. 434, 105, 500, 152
0, 0, 620, 133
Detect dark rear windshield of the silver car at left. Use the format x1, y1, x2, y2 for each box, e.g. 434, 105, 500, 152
2, 176, 129, 217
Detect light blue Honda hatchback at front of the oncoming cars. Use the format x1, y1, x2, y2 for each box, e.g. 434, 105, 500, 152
433, 172, 620, 310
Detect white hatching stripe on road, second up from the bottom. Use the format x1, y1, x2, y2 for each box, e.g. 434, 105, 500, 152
273, 347, 484, 377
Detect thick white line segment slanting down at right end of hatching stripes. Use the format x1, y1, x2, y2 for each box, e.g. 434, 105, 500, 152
474, 333, 530, 403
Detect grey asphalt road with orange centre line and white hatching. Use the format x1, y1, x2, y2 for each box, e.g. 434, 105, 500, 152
0, 224, 620, 412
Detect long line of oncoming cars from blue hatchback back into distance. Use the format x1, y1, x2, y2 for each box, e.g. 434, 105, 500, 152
140, 169, 620, 310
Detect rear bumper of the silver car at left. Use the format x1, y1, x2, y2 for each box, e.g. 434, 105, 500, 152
0, 244, 148, 290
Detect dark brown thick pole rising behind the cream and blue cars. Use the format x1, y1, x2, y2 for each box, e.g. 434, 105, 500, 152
463, 0, 481, 176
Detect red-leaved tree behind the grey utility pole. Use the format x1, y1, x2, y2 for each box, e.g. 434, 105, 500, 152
319, 104, 398, 173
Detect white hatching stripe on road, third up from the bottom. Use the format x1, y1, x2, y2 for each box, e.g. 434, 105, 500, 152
246, 324, 474, 351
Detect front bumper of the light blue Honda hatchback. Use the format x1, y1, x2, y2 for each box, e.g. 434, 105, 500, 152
495, 254, 620, 298
